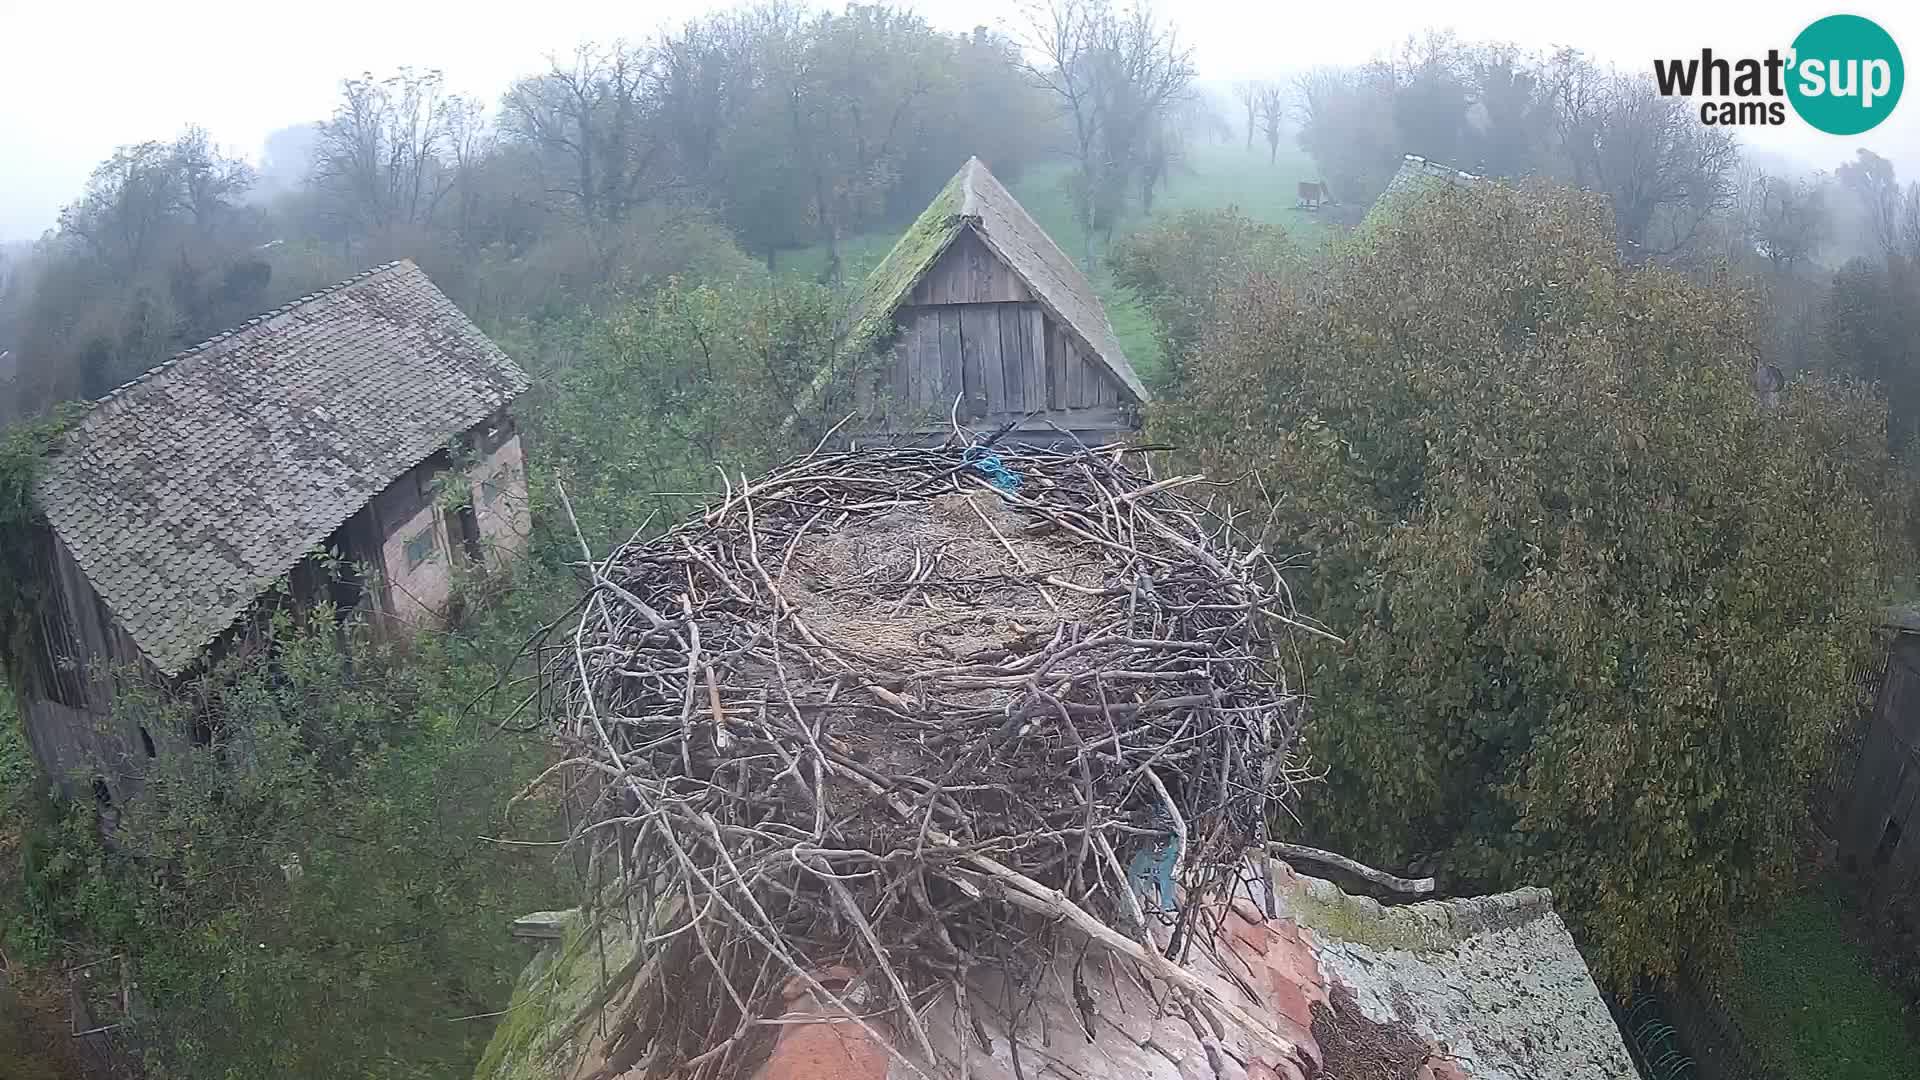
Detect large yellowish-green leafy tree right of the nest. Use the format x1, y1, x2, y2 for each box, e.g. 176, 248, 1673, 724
1158, 184, 1895, 984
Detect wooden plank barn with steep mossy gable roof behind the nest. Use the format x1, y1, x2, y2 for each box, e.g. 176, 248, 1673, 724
843, 158, 1146, 446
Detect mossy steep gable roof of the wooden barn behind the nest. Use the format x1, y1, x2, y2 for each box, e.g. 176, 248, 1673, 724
852, 158, 1148, 402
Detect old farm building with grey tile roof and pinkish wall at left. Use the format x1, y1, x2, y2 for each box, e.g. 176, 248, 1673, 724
6, 261, 530, 798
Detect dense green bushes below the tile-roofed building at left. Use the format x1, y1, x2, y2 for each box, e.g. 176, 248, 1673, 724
8, 568, 572, 1080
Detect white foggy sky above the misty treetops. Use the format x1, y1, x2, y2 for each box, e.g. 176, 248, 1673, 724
0, 0, 1920, 242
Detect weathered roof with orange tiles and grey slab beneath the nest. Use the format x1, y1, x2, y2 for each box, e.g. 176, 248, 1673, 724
478, 863, 1636, 1080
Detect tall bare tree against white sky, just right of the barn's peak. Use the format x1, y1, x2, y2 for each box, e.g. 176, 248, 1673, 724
1027, 0, 1194, 267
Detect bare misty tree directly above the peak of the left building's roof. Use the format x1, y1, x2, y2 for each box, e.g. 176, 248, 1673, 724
313, 67, 464, 236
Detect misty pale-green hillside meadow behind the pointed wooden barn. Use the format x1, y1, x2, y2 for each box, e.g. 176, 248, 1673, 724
780, 144, 1325, 382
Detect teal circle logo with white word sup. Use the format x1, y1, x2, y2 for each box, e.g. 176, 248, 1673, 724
1788, 15, 1907, 135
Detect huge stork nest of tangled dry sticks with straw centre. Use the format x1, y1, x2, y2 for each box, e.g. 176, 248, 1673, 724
547, 446, 1319, 1076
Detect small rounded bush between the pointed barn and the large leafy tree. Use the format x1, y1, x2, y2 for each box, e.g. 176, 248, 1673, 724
1108, 206, 1298, 384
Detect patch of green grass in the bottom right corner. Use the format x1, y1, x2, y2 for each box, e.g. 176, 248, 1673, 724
1726, 888, 1920, 1080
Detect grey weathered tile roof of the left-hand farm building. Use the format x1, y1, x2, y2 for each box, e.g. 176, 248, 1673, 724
36, 259, 528, 675
